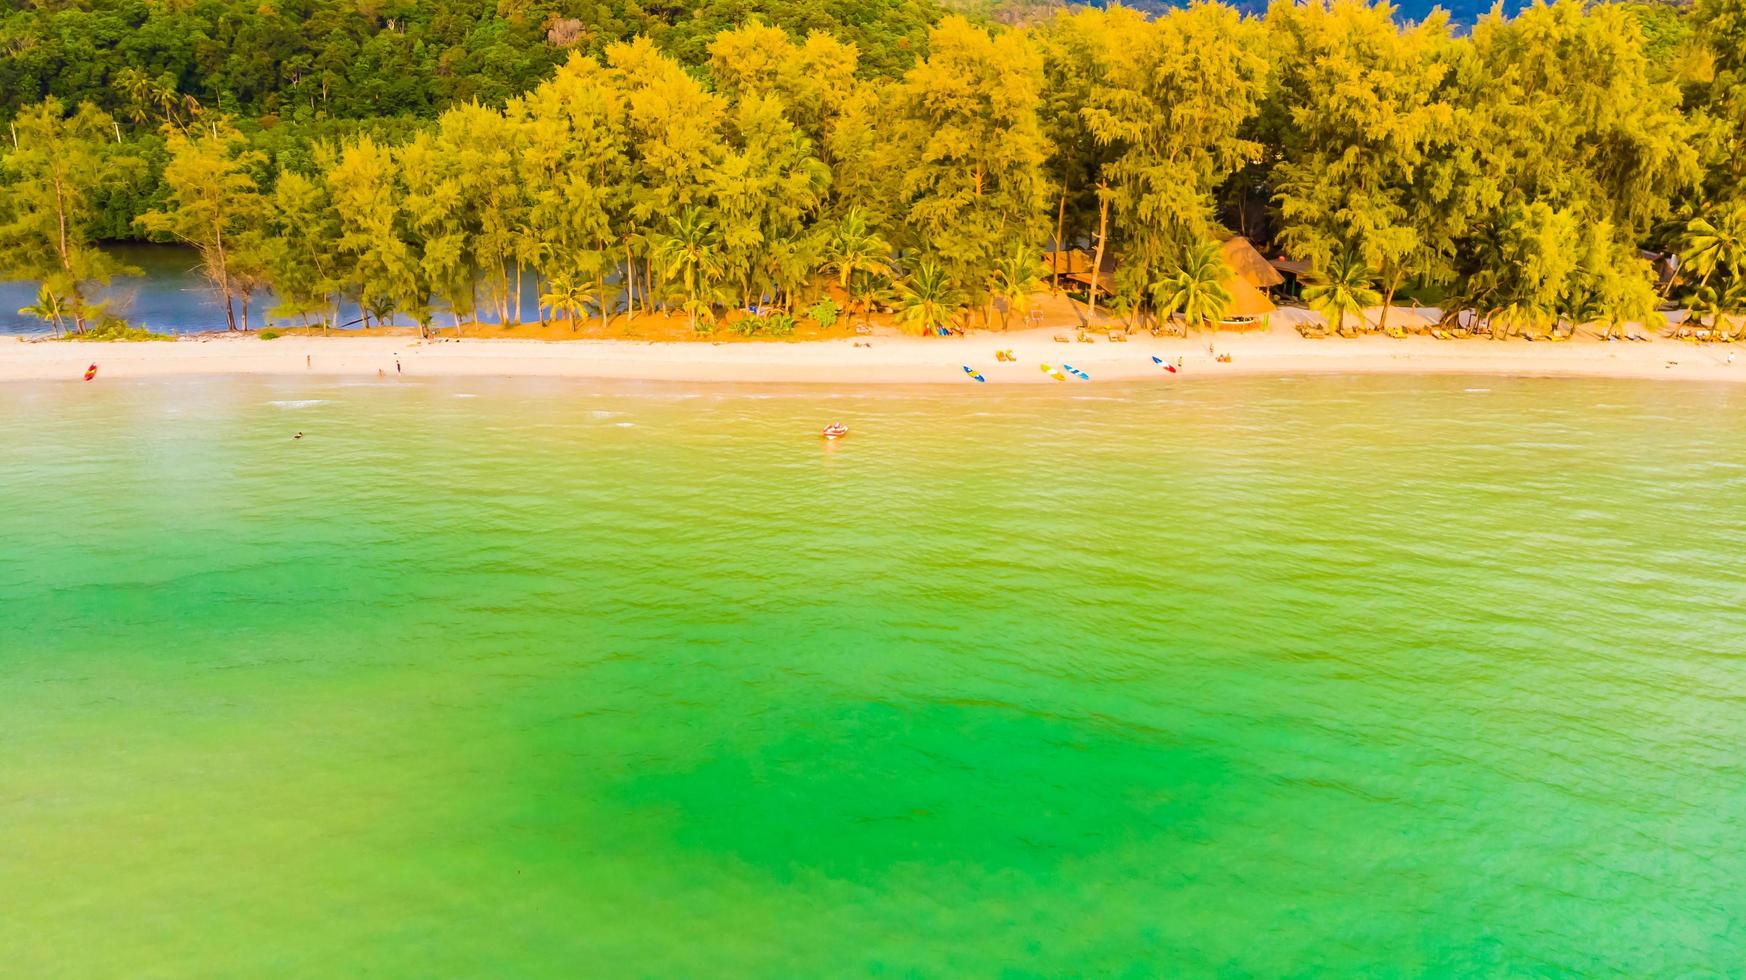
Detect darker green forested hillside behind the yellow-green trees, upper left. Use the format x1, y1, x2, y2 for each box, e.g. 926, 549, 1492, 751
0, 0, 939, 128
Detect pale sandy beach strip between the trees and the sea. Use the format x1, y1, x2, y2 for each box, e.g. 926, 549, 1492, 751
0, 325, 1746, 388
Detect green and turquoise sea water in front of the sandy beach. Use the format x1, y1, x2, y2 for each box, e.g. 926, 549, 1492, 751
0, 377, 1746, 977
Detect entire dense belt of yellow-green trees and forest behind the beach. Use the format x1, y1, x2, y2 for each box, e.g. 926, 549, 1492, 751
0, 0, 1746, 332
